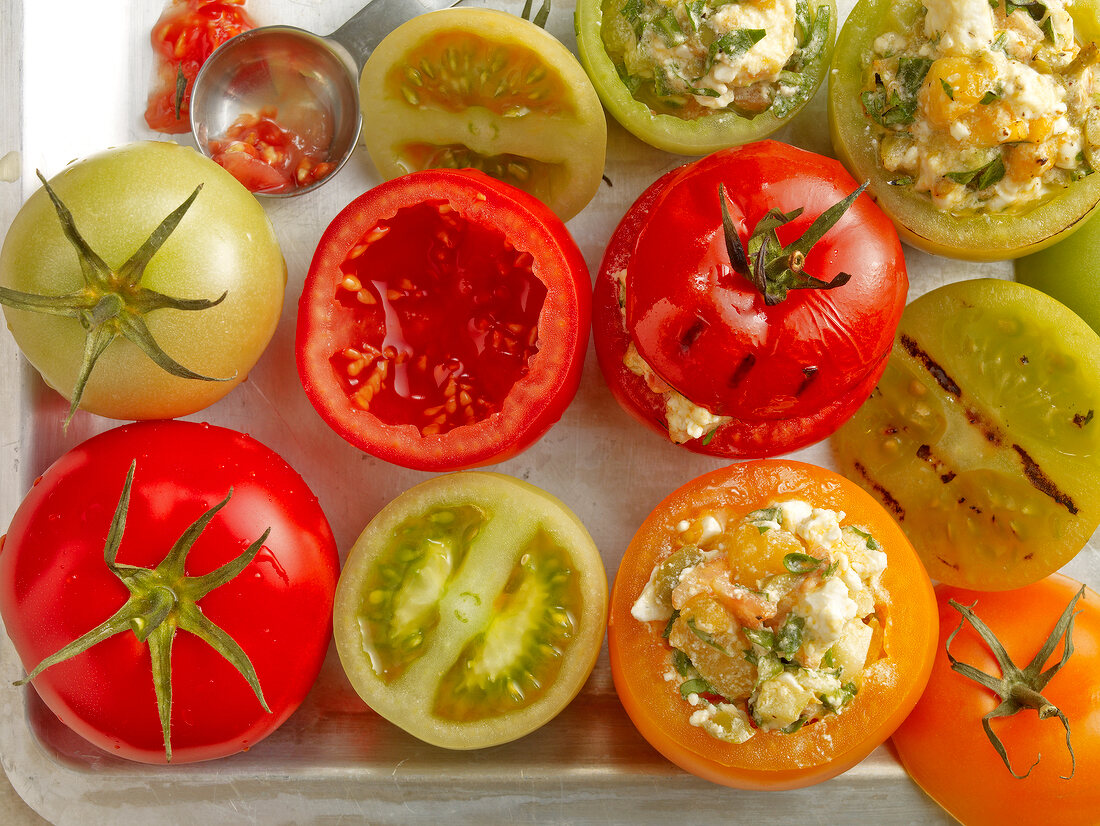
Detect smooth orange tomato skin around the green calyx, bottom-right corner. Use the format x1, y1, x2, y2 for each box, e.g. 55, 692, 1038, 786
893, 574, 1100, 826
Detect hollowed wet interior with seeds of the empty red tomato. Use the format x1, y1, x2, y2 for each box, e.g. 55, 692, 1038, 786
330, 201, 547, 436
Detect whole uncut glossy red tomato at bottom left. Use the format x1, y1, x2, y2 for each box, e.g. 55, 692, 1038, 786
0, 421, 339, 763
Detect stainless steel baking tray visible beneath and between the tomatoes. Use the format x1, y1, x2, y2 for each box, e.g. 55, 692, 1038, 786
0, 0, 1100, 825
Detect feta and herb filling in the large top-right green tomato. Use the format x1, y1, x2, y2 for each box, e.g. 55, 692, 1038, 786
862, 0, 1100, 212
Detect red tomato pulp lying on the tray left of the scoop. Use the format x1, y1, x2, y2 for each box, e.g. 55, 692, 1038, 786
145, 0, 256, 134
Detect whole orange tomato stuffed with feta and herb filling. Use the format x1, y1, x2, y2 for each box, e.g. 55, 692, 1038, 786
608, 460, 937, 790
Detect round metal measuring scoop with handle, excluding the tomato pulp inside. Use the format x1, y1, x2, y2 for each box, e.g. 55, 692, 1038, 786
190, 0, 459, 198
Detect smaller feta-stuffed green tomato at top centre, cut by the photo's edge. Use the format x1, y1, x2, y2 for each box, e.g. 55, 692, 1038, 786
574, 0, 837, 155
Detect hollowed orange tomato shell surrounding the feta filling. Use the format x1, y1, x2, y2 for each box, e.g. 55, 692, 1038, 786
608, 460, 937, 790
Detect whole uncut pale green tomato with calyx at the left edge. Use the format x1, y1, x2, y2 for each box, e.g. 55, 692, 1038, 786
0, 142, 286, 419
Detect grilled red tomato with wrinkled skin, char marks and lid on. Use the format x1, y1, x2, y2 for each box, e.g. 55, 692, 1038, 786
594, 141, 909, 458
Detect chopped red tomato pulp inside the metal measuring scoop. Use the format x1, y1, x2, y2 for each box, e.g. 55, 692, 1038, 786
210, 108, 333, 192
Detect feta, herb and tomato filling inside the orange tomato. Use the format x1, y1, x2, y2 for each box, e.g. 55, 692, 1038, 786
631, 499, 887, 744
